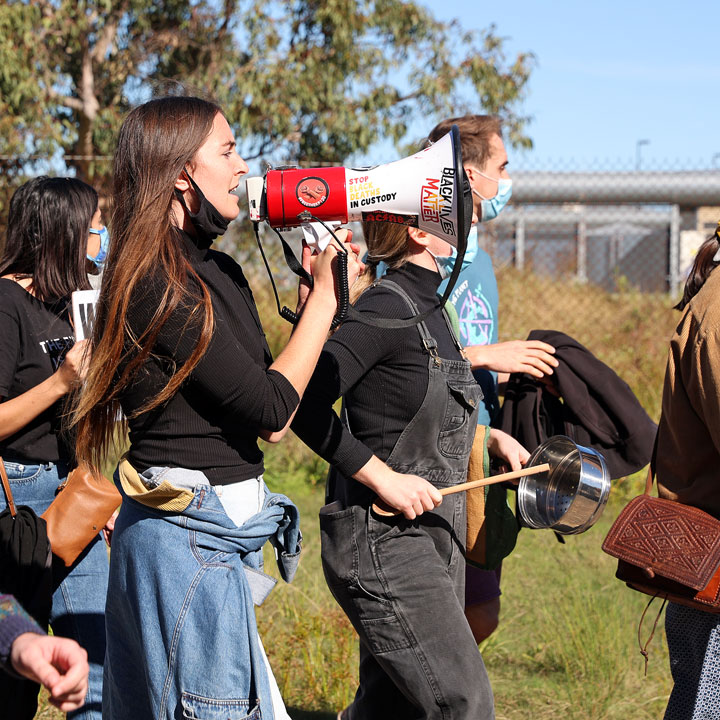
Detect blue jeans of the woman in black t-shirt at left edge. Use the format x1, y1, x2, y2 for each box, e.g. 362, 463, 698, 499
0, 459, 108, 720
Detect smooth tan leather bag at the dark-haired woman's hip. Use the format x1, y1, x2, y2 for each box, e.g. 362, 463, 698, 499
41, 465, 121, 567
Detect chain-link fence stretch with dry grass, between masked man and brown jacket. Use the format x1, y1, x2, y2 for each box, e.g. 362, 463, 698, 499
472, 169, 720, 419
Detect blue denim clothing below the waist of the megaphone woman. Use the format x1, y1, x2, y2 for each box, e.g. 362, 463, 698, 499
104, 468, 299, 720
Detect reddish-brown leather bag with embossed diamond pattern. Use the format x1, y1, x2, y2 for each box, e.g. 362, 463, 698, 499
602, 469, 720, 613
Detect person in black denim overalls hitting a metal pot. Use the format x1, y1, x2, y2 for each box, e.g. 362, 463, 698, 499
293, 224, 522, 720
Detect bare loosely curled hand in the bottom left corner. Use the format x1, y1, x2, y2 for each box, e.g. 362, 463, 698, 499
10, 632, 89, 712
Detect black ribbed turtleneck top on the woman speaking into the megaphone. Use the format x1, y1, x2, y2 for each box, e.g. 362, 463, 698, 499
121, 232, 299, 485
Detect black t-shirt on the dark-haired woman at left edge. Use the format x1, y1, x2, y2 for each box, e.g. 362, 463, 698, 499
0, 278, 75, 464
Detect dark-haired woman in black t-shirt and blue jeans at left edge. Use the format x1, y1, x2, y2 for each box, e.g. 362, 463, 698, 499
0, 177, 108, 720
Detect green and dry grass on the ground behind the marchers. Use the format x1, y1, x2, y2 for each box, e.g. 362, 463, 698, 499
37, 268, 679, 720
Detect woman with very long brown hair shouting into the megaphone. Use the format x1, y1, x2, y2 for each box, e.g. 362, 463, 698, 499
75, 97, 360, 720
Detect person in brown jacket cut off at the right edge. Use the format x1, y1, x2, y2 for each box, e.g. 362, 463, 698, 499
655, 226, 720, 720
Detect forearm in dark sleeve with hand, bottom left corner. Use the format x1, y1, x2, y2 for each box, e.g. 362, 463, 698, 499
0, 595, 89, 712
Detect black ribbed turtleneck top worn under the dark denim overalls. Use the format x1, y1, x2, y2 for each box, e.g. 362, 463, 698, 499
292, 263, 461, 477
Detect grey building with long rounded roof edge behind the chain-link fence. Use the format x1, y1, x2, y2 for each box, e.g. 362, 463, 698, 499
487, 170, 720, 294
